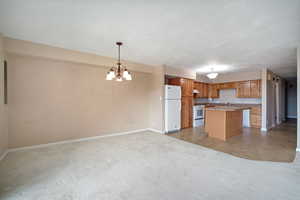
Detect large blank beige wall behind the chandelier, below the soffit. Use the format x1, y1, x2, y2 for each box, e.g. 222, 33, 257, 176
8, 53, 152, 148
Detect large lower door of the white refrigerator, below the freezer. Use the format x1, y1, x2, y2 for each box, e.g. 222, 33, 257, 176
165, 100, 181, 132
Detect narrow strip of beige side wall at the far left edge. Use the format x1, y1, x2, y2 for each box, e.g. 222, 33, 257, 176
0, 34, 8, 157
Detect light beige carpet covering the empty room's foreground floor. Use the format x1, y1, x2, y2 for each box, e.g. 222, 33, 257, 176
0, 132, 300, 200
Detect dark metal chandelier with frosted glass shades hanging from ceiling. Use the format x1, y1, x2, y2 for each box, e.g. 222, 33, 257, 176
106, 42, 132, 81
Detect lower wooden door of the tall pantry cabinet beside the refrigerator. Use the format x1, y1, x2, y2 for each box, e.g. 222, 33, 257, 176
181, 97, 193, 128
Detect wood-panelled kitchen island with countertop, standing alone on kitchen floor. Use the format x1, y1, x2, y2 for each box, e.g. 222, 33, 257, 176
205, 106, 249, 141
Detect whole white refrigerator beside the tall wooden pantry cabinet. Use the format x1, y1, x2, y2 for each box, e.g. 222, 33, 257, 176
165, 85, 181, 133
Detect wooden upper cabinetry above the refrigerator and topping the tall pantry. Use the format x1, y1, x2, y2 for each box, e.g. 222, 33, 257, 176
168, 78, 194, 97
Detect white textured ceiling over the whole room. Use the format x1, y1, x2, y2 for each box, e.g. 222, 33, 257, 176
0, 0, 300, 77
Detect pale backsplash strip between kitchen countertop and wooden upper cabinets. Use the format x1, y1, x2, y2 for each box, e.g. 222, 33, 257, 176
196, 89, 261, 104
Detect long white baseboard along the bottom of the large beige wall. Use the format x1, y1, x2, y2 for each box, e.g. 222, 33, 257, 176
8, 129, 148, 152
